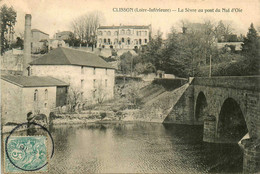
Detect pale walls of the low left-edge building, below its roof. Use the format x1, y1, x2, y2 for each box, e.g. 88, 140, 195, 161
1, 80, 56, 125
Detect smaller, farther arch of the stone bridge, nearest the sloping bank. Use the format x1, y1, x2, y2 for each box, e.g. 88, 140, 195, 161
195, 92, 208, 124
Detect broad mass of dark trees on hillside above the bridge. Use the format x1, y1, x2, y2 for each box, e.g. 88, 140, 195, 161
133, 21, 260, 77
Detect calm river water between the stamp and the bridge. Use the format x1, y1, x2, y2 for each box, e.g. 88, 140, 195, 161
44, 123, 243, 174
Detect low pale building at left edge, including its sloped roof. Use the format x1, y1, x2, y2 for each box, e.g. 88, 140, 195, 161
1, 75, 68, 124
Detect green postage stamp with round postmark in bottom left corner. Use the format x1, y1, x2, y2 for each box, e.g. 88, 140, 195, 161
5, 136, 48, 173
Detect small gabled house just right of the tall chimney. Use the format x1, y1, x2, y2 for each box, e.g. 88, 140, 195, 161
31, 29, 49, 53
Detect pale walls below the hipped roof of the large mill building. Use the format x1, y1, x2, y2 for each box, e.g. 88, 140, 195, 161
32, 65, 115, 102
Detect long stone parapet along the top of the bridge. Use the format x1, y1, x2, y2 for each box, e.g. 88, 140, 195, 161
193, 76, 260, 91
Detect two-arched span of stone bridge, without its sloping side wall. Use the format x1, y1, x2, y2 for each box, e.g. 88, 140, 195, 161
192, 76, 260, 143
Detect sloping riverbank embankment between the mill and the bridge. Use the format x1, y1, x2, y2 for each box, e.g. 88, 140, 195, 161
52, 83, 189, 124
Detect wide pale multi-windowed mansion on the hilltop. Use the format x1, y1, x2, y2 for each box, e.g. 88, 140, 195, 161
97, 25, 151, 49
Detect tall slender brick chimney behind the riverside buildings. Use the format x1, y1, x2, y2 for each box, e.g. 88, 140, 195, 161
23, 14, 32, 76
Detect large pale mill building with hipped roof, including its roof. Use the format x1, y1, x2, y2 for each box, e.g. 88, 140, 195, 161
30, 47, 115, 104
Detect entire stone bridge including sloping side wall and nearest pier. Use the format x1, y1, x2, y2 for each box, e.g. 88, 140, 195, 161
163, 76, 260, 173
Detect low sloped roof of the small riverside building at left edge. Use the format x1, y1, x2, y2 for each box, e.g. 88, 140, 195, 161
1, 75, 69, 87
